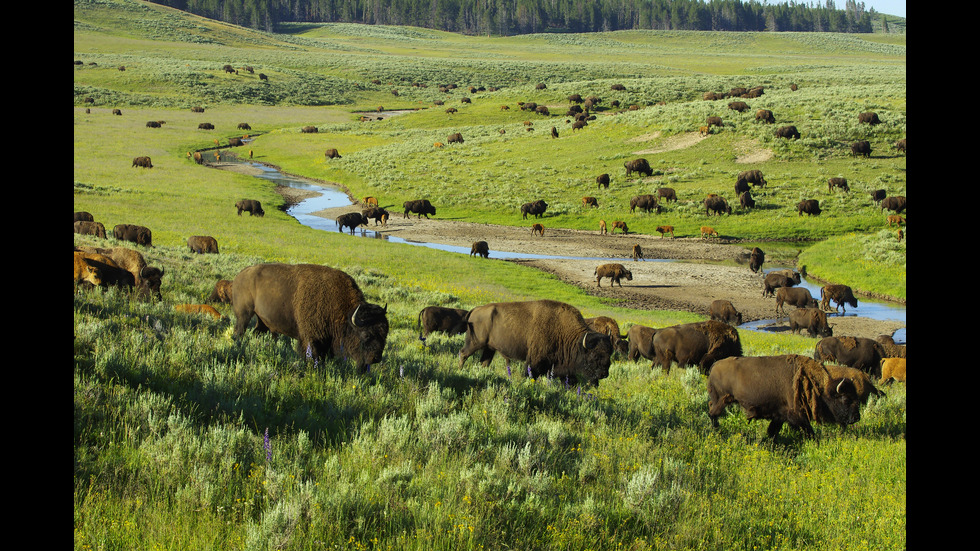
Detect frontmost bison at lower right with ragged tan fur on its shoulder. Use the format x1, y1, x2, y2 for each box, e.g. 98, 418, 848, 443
708, 354, 861, 440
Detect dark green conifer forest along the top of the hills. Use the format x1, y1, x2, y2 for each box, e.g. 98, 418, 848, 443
151, 0, 881, 35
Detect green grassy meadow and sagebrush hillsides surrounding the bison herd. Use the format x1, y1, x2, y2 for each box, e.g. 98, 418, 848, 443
73, 0, 907, 550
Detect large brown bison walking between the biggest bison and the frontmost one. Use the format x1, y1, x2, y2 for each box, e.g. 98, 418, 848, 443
459, 300, 613, 385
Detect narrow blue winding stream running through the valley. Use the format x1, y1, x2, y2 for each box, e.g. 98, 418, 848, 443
222, 152, 906, 344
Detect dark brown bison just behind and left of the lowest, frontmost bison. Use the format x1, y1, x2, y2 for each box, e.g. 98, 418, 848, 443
653, 320, 742, 374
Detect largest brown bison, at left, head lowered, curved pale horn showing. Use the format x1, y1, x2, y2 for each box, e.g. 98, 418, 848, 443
232, 263, 388, 372
